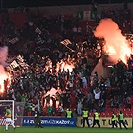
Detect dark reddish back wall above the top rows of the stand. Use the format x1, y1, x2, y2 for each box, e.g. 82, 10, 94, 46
8, 3, 133, 20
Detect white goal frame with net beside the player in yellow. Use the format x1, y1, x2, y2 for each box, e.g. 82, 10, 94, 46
0, 100, 24, 126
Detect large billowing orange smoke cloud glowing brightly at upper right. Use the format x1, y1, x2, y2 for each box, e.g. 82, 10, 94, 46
94, 18, 131, 64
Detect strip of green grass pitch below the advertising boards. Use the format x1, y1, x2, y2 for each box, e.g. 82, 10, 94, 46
0, 127, 133, 133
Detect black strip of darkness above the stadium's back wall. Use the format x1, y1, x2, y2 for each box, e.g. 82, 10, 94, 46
0, 0, 133, 8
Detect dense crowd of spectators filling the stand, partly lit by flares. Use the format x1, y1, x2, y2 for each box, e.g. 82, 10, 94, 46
0, 3, 133, 116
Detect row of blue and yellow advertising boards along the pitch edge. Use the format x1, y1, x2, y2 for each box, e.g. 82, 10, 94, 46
0, 117, 133, 128
